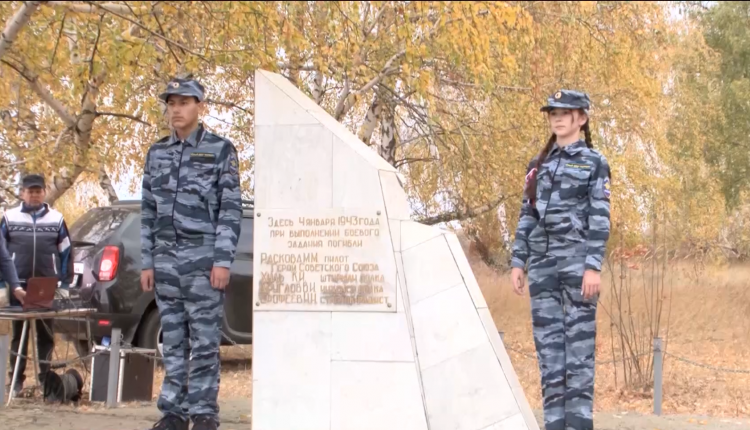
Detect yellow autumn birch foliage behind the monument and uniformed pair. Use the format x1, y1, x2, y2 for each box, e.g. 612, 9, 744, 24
0, 1, 746, 262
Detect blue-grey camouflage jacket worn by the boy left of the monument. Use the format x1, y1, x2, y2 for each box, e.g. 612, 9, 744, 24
141, 126, 242, 269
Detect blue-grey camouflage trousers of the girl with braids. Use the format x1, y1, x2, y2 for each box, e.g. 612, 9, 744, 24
529, 255, 598, 430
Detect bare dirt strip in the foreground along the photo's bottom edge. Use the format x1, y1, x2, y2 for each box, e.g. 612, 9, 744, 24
0, 399, 750, 430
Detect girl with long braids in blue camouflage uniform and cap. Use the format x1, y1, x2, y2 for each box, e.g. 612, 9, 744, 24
511, 90, 610, 430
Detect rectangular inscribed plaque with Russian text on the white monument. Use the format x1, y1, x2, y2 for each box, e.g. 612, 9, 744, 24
253, 209, 396, 312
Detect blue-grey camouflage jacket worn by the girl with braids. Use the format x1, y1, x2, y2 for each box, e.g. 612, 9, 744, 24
511, 140, 610, 271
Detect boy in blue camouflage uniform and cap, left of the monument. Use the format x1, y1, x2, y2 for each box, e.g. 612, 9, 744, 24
141, 79, 242, 430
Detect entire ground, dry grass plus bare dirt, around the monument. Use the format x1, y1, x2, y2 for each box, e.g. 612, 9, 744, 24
0, 255, 750, 430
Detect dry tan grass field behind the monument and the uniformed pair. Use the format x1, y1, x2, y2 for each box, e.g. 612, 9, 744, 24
0, 255, 750, 418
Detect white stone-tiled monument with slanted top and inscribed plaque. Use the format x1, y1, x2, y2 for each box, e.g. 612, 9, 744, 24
252, 71, 539, 430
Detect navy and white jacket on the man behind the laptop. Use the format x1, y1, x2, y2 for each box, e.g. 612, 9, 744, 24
0, 203, 73, 298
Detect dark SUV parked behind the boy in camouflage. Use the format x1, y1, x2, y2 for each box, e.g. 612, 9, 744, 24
55, 200, 253, 355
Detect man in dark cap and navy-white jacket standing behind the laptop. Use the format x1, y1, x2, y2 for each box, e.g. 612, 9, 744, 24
0, 174, 73, 396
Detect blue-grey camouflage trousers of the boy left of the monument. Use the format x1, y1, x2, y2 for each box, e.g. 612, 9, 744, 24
154, 246, 224, 424
